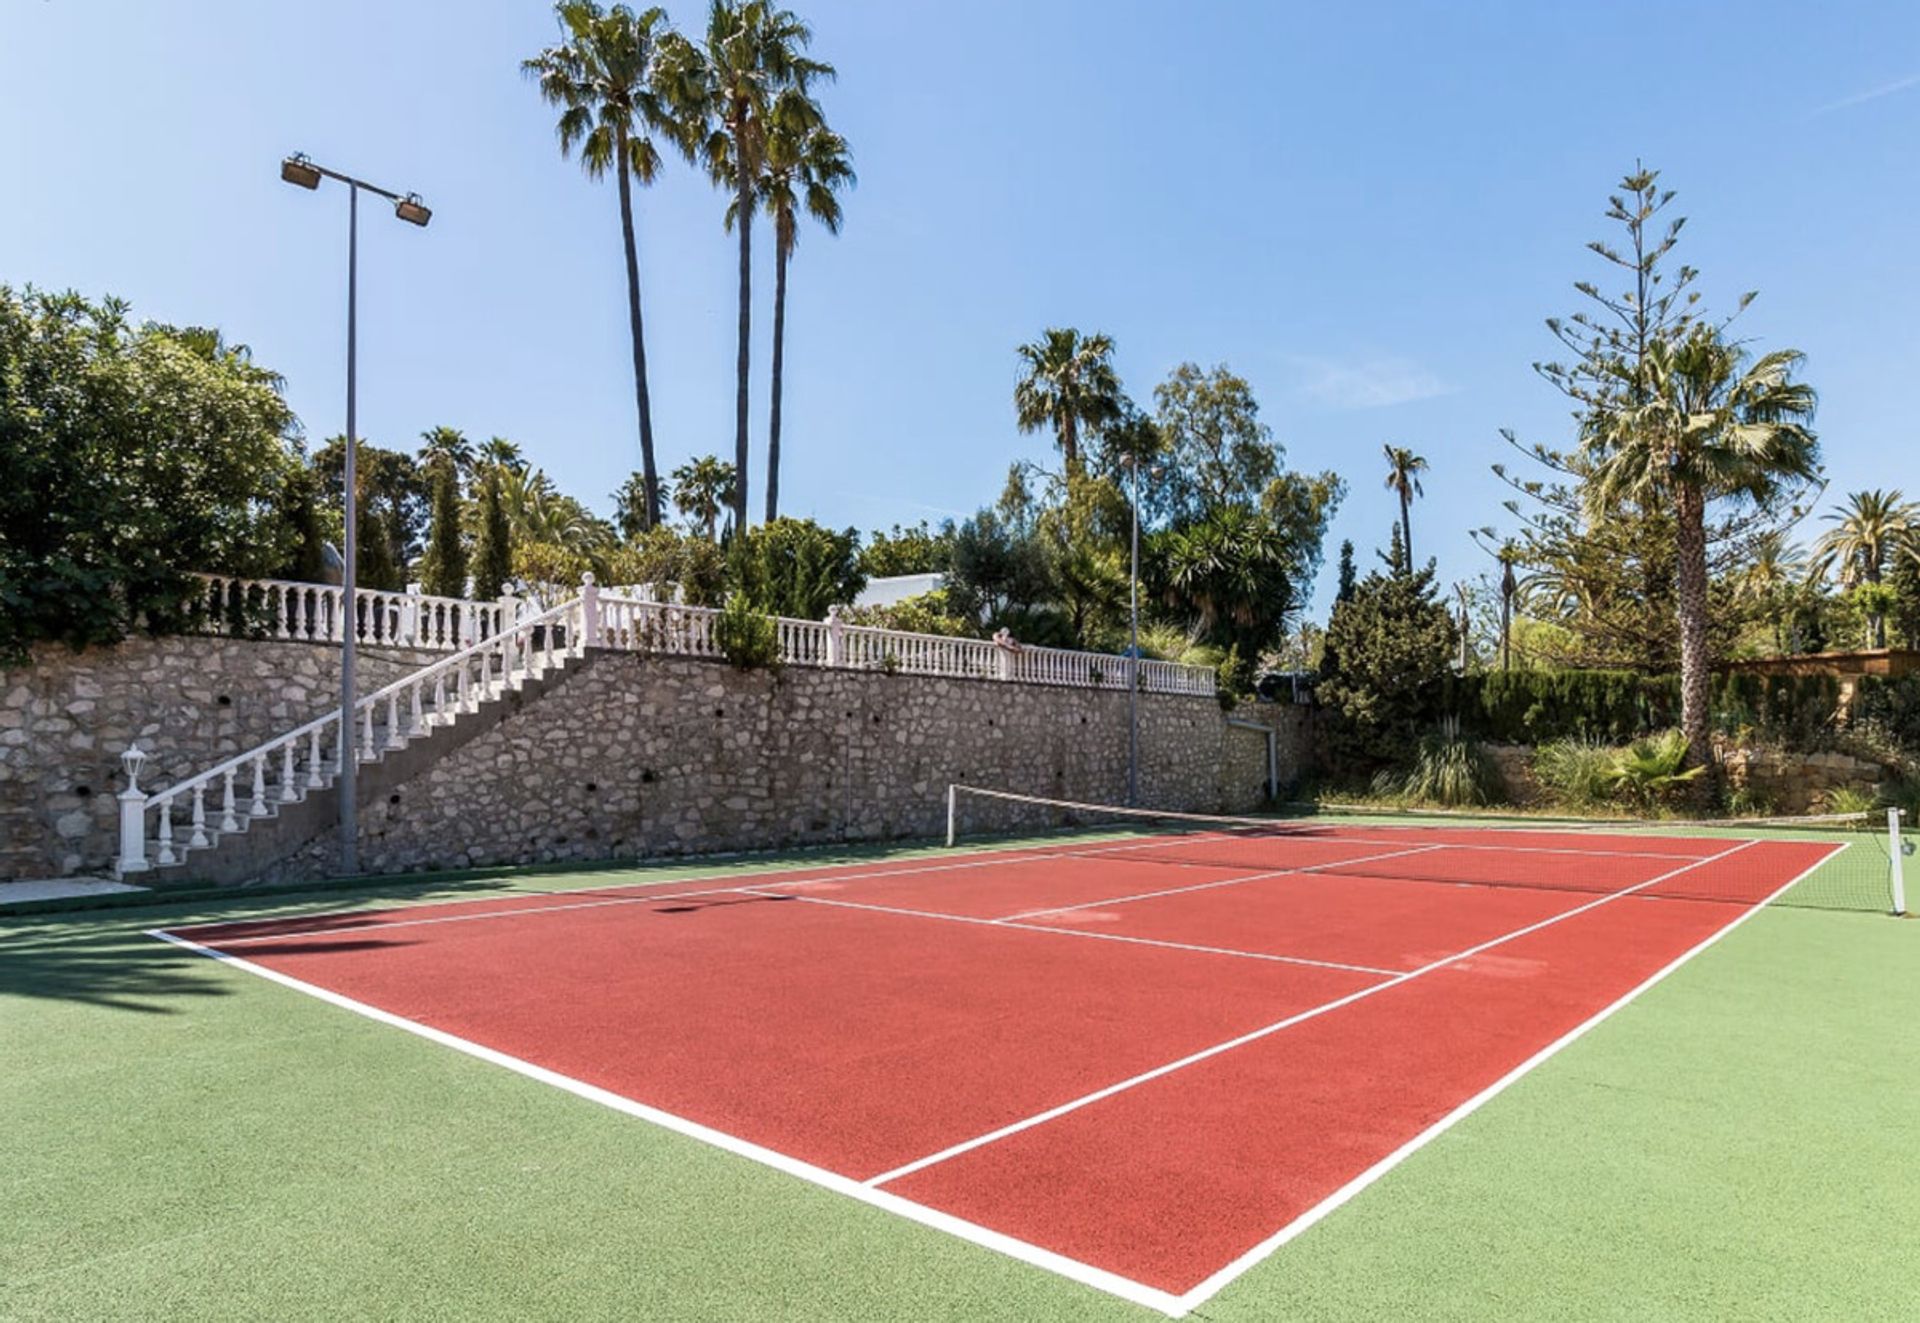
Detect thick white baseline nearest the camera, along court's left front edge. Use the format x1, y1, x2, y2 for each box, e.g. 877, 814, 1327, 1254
148, 927, 1185, 1317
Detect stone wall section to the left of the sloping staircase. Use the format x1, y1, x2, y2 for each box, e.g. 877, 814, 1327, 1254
0, 637, 444, 881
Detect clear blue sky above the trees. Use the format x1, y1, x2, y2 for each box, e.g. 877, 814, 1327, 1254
0, 0, 1920, 613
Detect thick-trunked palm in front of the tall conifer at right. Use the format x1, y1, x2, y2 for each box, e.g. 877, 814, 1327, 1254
1582, 326, 1820, 766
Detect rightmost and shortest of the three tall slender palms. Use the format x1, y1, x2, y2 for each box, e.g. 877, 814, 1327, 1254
748, 90, 858, 520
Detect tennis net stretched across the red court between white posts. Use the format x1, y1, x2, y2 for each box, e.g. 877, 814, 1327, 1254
947, 785, 1914, 912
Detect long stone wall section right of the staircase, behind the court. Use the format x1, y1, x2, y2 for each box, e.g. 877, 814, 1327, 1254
267, 653, 1306, 881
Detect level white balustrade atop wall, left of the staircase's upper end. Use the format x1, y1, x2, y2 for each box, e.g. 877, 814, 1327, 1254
192, 574, 520, 653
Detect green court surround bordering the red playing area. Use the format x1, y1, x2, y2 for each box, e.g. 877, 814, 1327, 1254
0, 856, 1920, 1323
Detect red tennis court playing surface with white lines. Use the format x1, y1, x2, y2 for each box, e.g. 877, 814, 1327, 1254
156, 828, 1839, 1315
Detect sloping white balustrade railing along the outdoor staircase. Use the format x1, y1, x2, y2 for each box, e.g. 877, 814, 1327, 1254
117, 584, 593, 874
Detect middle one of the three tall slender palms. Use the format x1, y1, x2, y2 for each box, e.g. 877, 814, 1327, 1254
662, 0, 833, 528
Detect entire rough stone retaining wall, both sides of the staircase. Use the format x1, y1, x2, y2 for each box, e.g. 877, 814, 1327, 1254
0, 637, 1309, 879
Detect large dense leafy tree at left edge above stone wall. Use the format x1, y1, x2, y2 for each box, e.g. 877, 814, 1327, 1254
0, 286, 300, 661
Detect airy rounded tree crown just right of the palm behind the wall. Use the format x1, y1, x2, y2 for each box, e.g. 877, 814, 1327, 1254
1154, 363, 1283, 522
